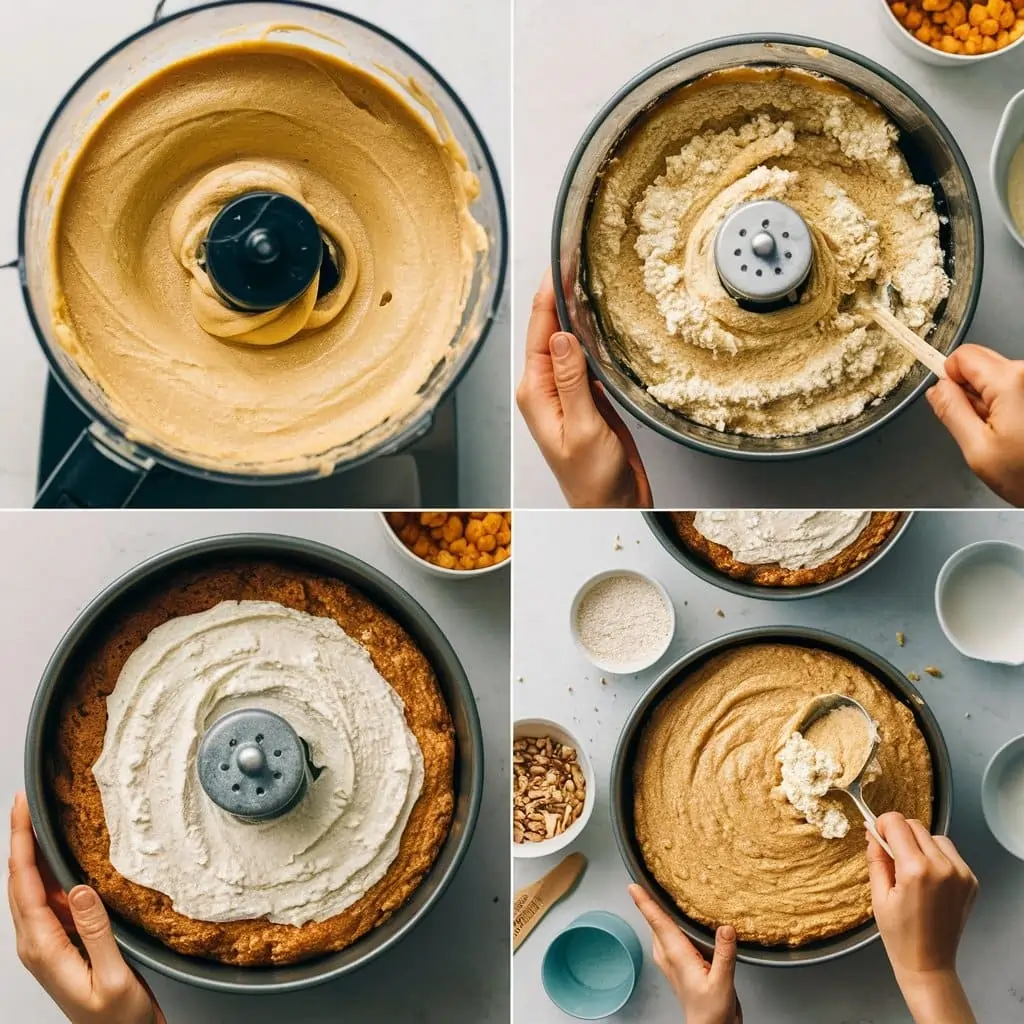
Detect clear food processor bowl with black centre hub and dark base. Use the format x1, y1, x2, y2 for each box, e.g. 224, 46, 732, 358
17, 0, 507, 507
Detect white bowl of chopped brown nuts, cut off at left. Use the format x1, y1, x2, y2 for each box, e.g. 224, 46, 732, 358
512, 718, 597, 858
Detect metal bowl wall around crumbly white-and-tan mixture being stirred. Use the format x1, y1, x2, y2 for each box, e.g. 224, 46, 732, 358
551, 35, 983, 460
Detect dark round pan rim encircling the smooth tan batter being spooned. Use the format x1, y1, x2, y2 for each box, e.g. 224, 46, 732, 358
610, 626, 953, 967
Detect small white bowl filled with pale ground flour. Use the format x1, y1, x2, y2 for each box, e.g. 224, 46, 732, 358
569, 569, 676, 676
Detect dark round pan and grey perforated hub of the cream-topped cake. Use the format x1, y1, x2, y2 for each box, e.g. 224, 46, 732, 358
25, 534, 483, 993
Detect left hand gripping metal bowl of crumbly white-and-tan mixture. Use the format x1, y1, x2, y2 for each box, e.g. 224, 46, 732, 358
516, 270, 653, 508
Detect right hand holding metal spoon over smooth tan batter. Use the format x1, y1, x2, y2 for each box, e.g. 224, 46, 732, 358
867, 812, 978, 1024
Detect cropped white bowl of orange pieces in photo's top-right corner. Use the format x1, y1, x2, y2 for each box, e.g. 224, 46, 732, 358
880, 0, 1024, 68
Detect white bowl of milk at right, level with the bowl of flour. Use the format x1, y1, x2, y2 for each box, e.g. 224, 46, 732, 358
935, 541, 1024, 666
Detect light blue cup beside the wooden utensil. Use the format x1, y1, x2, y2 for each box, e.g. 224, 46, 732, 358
541, 910, 643, 1021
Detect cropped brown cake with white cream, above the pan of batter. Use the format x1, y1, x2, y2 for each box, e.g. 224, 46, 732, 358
669, 509, 902, 587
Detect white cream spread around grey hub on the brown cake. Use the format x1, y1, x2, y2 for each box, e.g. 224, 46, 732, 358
92, 601, 423, 926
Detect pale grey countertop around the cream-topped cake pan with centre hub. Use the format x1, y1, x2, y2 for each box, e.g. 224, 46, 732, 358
0, 511, 509, 1024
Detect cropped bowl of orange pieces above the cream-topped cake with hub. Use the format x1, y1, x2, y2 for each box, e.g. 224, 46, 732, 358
380, 512, 512, 580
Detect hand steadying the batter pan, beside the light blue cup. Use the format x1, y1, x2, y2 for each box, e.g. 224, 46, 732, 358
630, 886, 743, 1024
